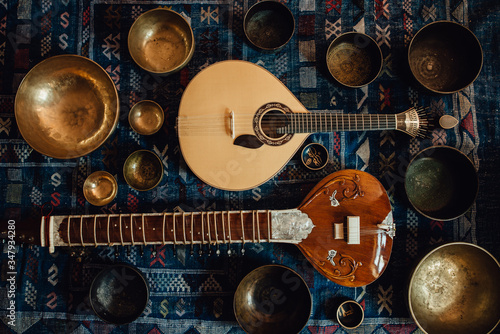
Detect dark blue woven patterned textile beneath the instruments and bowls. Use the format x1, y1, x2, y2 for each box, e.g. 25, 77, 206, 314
0, 0, 500, 334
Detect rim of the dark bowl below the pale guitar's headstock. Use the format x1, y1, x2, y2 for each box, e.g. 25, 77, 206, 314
404, 145, 479, 221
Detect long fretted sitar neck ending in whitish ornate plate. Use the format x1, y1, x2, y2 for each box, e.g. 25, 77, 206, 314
41, 209, 313, 252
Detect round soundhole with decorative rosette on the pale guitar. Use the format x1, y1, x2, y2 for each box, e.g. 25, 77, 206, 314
253, 102, 293, 146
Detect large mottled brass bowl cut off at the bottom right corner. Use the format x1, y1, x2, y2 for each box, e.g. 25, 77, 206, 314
408, 242, 500, 334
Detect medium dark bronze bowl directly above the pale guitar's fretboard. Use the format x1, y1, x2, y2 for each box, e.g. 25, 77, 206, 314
326, 32, 383, 88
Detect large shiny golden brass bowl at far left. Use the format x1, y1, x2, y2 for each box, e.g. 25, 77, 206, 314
14, 55, 119, 159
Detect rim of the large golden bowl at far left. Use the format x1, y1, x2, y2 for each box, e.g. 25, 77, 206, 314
14, 54, 120, 160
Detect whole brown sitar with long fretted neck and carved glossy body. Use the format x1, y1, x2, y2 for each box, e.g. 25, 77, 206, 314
0, 170, 395, 287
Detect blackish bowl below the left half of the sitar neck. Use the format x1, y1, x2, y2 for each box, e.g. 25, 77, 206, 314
89, 264, 149, 325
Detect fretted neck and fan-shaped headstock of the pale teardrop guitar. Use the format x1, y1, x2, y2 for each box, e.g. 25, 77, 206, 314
278, 108, 429, 137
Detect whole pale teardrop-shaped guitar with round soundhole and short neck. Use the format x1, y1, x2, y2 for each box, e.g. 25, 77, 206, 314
177, 60, 430, 191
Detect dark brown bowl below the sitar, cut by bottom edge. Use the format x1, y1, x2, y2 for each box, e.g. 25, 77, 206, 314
233, 265, 312, 334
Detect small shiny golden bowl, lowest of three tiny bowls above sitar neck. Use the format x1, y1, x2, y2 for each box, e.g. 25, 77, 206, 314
83, 171, 118, 206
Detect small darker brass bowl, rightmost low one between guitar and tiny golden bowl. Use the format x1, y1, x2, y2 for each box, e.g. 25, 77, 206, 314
123, 150, 163, 191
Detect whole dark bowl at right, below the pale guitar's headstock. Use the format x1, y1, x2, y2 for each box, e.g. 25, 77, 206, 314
405, 146, 479, 220
